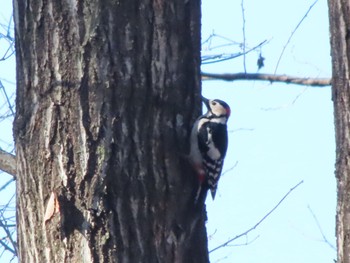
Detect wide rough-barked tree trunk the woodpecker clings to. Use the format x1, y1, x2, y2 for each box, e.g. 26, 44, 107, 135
14, 0, 208, 263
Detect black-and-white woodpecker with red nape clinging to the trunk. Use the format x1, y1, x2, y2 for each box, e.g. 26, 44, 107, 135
190, 97, 231, 202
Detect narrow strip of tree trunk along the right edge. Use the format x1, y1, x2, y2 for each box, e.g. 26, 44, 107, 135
328, 0, 350, 263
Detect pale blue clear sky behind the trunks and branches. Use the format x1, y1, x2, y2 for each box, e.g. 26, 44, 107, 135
0, 0, 336, 263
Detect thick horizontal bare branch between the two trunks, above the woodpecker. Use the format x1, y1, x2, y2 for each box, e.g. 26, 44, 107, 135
202, 72, 331, 87
